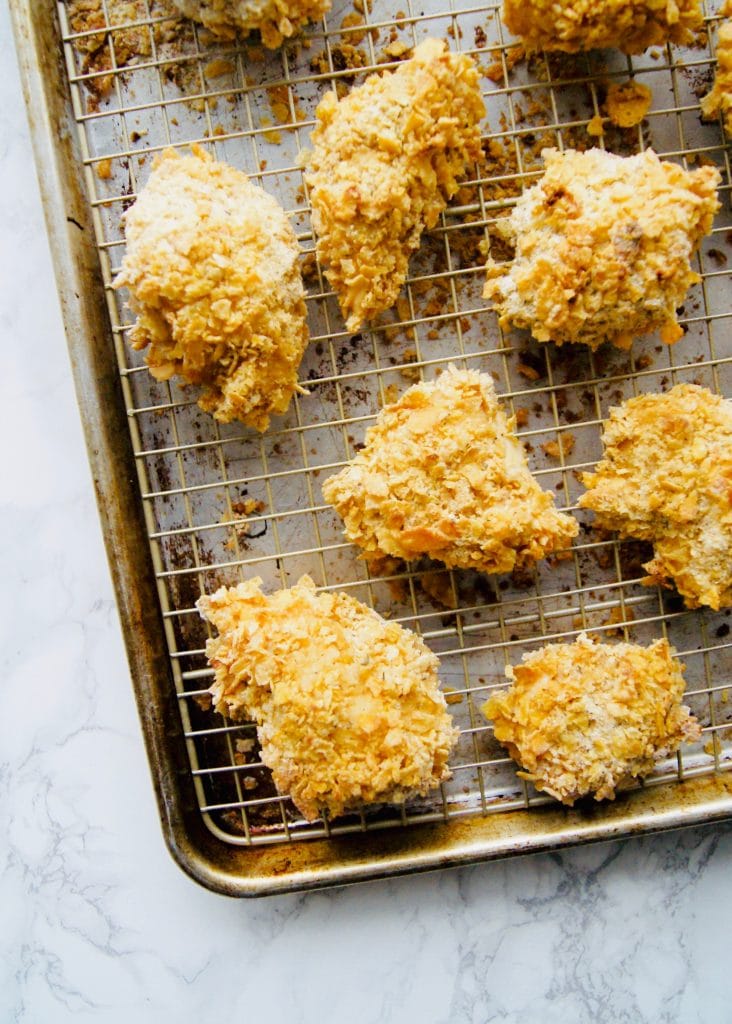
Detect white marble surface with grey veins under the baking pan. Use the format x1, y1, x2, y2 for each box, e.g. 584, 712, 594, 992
0, 5, 732, 1024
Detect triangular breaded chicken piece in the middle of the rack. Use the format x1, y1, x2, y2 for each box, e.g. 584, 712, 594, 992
322, 367, 577, 572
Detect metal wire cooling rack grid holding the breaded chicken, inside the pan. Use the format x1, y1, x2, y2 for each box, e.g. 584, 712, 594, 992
57, 0, 732, 844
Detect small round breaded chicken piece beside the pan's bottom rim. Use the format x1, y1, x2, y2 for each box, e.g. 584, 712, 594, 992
482, 633, 701, 807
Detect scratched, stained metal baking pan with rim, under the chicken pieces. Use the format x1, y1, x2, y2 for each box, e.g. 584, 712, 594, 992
12, 0, 732, 895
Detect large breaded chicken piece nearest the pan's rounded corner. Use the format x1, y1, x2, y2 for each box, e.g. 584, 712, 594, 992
198, 577, 459, 820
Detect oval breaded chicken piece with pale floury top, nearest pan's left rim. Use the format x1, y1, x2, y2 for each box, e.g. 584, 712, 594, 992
115, 146, 308, 430
